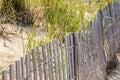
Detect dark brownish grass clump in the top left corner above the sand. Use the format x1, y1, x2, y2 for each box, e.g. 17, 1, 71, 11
0, 0, 38, 26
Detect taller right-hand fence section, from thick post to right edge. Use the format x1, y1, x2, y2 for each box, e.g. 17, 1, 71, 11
65, 0, 120, 80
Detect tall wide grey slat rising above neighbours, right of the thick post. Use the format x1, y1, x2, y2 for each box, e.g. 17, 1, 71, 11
94, 11, 106, 80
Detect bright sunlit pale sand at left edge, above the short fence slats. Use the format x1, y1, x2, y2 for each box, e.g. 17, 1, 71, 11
0, 24, 27, 71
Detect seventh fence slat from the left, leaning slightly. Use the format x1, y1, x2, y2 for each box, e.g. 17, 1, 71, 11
36, 47, 43, 80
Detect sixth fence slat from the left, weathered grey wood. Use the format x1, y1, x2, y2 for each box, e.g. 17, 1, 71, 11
32, 49, 37, 80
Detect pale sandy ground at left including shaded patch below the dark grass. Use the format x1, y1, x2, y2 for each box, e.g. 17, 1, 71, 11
0, 24, 46, 73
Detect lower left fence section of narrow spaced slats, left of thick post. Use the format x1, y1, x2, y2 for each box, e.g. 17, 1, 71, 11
2, 40, 66, 80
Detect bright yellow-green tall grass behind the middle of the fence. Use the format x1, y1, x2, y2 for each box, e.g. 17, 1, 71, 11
40, 0, 114, 38
